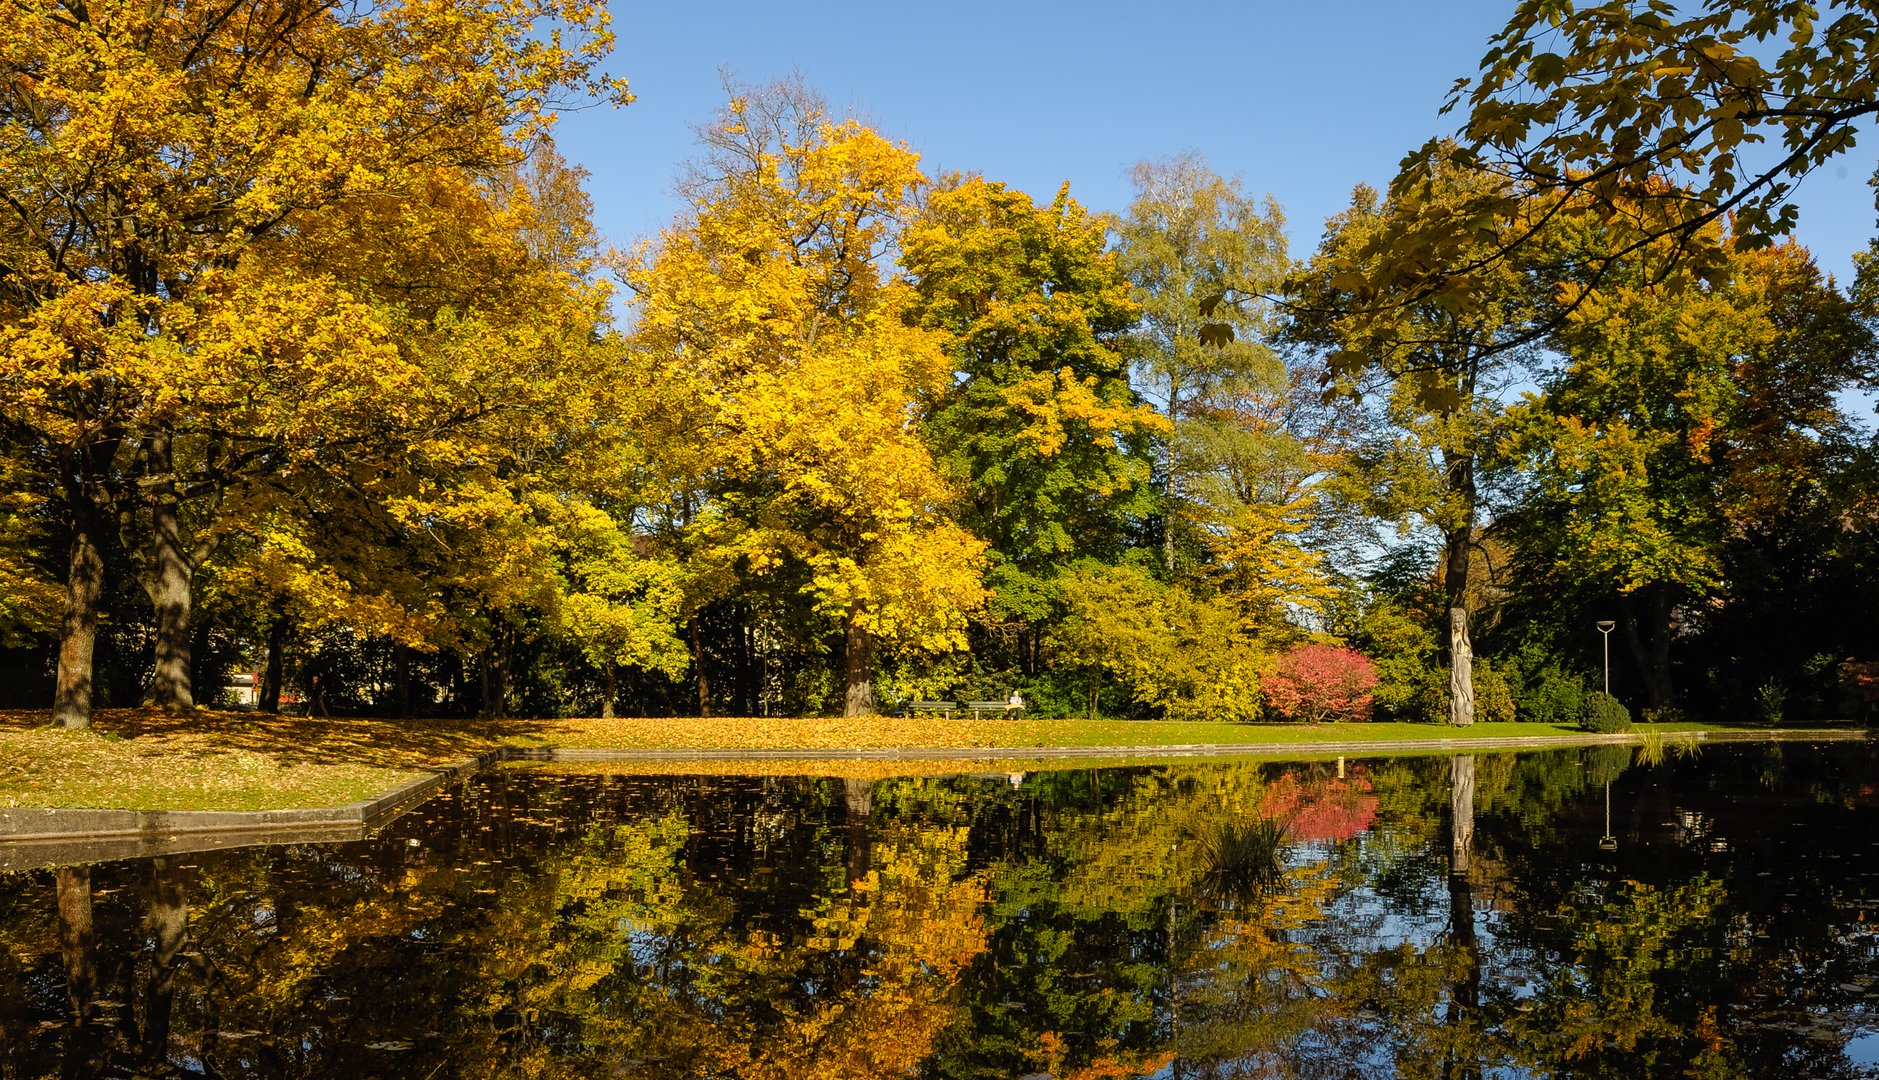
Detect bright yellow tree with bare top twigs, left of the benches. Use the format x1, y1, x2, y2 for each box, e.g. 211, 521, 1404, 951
626, 86, 983, 716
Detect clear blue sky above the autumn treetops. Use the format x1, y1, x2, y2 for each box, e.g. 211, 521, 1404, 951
556, 0, 1873, 280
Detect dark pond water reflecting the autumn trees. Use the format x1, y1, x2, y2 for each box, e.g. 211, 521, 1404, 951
0, 744, 1879, 1080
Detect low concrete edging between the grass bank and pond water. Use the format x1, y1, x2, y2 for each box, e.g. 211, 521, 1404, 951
0, 729, 1871, 872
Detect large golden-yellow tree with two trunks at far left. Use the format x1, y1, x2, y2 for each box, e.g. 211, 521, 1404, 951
0, 0, 624, 725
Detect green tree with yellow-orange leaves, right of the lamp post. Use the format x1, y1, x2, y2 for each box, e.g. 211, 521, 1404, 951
1509, 233, 1873, 708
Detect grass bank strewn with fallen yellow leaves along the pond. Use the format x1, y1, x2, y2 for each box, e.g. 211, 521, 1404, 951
0, 708, 1826, 810
